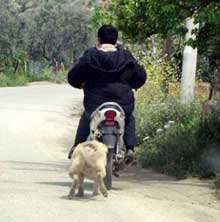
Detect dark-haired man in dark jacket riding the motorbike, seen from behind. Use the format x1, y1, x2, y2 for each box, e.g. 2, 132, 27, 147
68, 25, 146, 158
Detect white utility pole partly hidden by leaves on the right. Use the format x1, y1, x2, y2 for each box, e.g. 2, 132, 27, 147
181, 18, 199, 104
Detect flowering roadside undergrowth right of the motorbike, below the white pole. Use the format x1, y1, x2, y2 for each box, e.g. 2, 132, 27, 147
135, 89, 220, 178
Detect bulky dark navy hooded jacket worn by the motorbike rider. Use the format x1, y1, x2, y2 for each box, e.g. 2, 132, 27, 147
68, 47, 146, 113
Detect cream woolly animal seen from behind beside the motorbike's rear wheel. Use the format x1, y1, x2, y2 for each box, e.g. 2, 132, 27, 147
68, 141, 108, 199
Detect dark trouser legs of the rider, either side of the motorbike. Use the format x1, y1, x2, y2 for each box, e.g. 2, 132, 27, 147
74, 112, 137, 149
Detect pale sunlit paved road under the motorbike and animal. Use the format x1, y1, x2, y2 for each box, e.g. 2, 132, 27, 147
0, 84, 220, 222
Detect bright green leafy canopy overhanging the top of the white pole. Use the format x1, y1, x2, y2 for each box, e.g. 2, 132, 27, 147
93, 0, 220, 89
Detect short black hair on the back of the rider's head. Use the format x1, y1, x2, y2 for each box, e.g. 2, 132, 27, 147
98, 25, 118, 45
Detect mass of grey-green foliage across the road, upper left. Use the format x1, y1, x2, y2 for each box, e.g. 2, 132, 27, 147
0, 0, 93, 76
